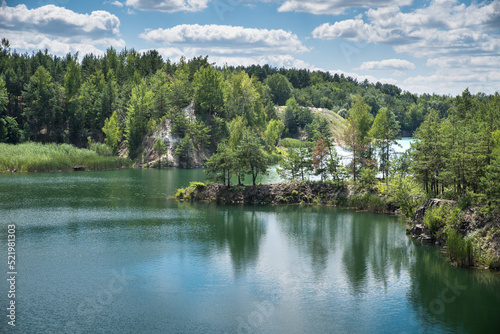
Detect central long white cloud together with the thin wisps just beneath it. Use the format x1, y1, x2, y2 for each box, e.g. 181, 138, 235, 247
140, 24, 311, 68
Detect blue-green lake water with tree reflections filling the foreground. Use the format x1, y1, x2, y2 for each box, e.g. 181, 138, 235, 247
0, 169, 500, 334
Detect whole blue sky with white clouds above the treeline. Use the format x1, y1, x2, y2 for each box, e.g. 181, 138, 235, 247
0, 0, 500, 96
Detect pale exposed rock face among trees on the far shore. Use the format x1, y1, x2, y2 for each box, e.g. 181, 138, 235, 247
142, 102, 208, 168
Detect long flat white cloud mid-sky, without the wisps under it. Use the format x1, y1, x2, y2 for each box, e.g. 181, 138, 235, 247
140, 24, 309, 56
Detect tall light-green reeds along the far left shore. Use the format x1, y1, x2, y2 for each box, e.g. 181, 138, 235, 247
0, 143, 130, 172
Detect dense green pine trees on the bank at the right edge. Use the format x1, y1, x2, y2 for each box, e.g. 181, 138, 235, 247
412, 90, 500, 210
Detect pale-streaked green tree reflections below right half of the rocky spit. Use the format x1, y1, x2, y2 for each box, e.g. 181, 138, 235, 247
279, 207, 411, 295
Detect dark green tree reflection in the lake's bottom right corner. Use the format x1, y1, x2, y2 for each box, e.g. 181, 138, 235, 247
407, 246, 500, 333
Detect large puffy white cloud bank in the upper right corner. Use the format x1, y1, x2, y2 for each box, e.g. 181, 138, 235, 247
312, 0, 500, 57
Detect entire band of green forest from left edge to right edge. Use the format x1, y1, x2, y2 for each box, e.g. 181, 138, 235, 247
0, 39, 500, 211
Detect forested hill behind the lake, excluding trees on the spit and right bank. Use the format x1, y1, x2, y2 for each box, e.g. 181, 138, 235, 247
0, 39, 492, 158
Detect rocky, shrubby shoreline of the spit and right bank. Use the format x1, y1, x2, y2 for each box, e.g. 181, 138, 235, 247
173, 181, 500, 271
